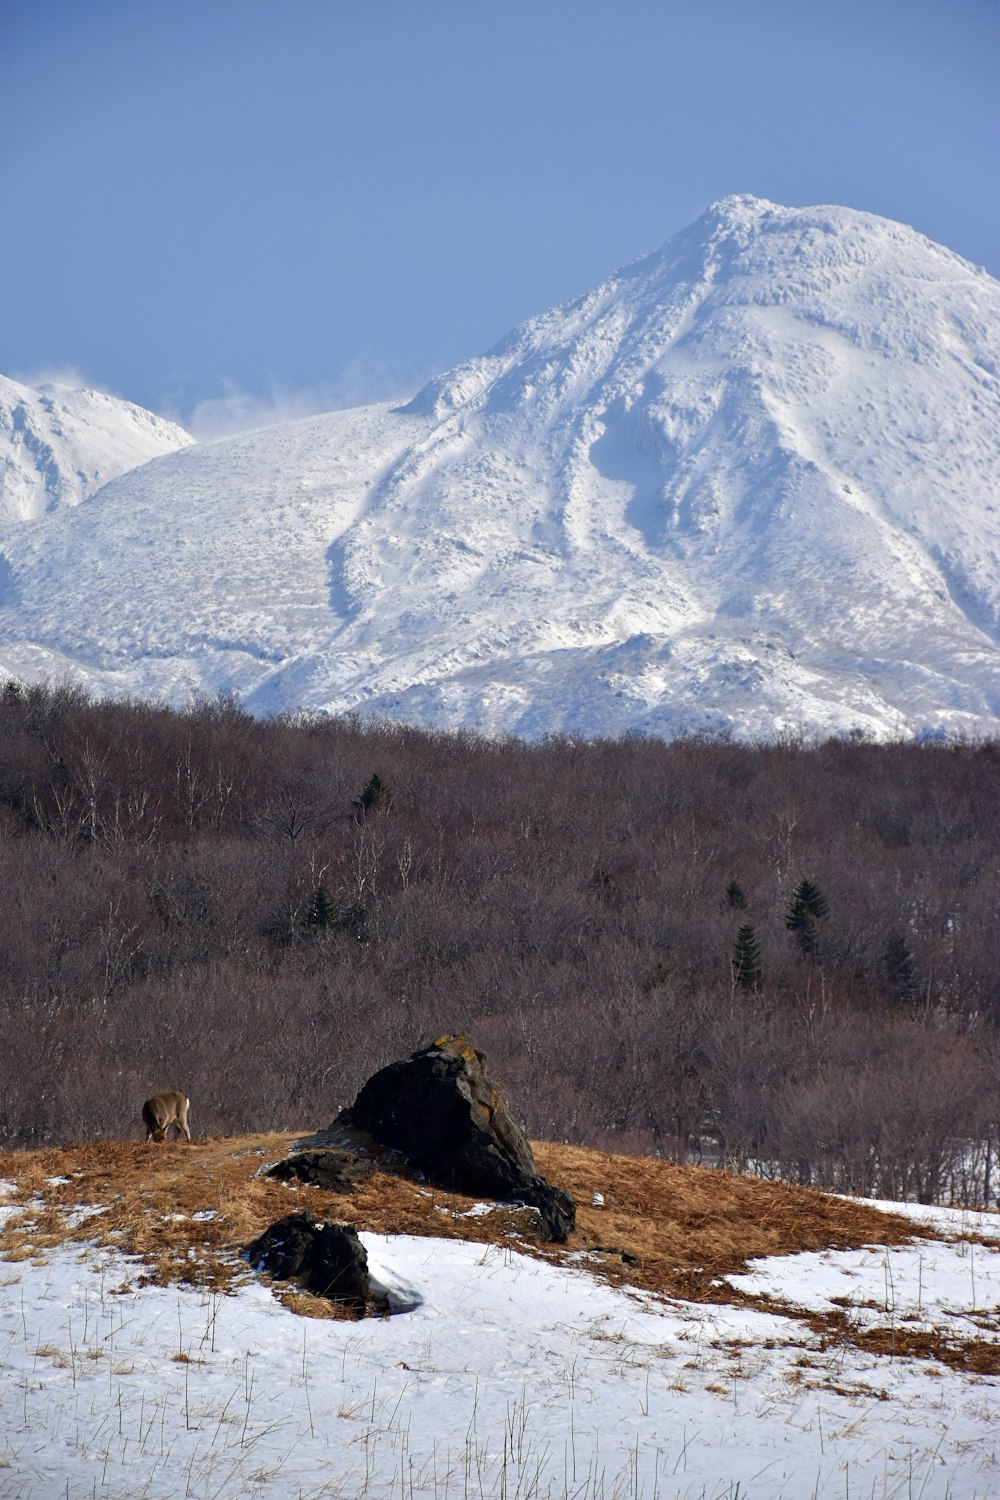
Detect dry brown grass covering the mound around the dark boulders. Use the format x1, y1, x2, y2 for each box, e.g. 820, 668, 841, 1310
0, 1133, 1000, 1374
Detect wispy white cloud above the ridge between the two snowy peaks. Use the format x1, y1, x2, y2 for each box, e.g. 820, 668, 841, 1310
179, 359, 430, 443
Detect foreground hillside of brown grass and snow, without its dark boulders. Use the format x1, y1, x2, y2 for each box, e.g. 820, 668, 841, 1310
0, 1133, 1000, 1500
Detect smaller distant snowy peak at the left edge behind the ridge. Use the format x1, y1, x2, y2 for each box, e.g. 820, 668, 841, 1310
0, 377, 193, 524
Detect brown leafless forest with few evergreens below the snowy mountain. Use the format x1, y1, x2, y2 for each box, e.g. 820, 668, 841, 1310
0, 684, 1000, 1202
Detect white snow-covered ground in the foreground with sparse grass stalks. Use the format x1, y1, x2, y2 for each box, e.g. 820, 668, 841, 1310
0, 1205, 1000, 1500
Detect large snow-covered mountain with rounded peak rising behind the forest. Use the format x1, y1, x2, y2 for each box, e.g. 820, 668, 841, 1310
0, 197, 1000, 737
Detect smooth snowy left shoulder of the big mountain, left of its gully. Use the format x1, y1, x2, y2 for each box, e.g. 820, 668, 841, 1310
0, 408, 426, 702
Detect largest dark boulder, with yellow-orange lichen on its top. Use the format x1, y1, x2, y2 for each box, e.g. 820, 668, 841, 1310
337, 1037, 576, 1241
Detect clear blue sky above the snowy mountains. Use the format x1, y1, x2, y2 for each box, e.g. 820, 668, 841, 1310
0, 0, 1000, 432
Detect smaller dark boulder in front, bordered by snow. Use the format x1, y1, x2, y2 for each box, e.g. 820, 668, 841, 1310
246, 1214, 370, 1313
